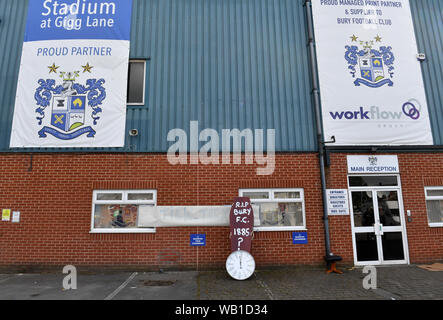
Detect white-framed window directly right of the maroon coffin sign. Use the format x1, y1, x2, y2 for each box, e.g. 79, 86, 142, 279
239, 189, 306, 231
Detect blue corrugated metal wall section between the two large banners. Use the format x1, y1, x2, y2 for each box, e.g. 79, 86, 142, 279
128, 0, 315, 151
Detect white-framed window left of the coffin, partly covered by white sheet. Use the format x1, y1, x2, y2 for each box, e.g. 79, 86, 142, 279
91, 190, 157, 233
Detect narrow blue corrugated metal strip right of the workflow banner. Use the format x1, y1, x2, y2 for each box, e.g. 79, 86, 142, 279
410, 0, 443, 145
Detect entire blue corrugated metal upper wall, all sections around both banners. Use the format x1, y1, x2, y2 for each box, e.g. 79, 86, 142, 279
0, 0, 443, 152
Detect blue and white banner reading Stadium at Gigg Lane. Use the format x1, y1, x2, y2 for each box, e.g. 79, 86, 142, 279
10, 0, 132, 148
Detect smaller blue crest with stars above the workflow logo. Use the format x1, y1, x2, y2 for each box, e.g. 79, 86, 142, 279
345, 35, 395, 88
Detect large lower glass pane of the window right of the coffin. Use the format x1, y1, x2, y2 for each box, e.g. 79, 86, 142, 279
259, 202, 304, 227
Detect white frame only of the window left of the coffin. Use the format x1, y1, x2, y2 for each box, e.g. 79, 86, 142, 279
90, 190, 157, 233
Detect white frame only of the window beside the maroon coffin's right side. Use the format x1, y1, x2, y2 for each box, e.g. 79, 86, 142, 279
239, 188, 308, 231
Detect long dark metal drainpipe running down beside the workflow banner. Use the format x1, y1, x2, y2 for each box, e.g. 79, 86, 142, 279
305, 0, 333, 256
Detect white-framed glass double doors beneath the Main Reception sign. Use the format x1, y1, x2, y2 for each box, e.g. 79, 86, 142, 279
349, 181, 409, 265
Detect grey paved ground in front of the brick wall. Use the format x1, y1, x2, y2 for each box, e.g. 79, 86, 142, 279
0, 266, 443, 301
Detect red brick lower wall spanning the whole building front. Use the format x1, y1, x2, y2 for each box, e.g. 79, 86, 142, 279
0, 153, 443, 269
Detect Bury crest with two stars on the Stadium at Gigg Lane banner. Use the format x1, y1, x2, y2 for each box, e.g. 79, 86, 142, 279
34, 64, 106, 140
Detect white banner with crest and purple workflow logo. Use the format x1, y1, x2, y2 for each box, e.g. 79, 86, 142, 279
312, 0, 433, 145
